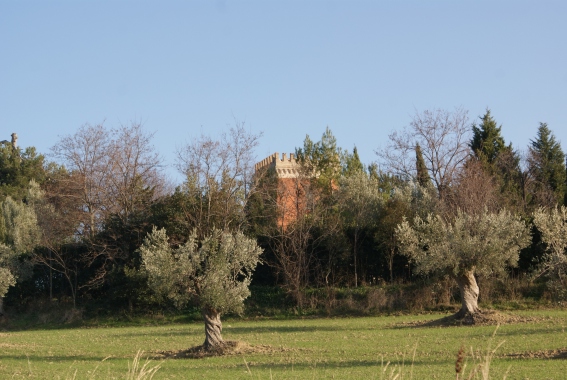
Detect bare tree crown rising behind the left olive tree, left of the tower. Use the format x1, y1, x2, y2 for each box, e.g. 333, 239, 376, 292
177, 123, 261, 237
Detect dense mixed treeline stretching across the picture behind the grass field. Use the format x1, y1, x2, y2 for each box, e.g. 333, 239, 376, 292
0, 108, 567, 323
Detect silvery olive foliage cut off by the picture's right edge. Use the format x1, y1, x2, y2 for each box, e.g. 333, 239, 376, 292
534, 206, 567, 270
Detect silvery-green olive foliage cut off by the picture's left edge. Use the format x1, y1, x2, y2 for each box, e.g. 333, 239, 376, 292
0, 181, 41, 298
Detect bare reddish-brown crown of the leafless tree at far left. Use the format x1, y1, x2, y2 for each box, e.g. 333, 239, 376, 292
51, 123, 165, 238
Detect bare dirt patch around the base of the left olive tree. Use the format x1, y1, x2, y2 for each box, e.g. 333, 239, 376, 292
156, 341, 292, 359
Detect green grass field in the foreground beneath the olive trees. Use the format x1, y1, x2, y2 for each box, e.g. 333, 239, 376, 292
0, 310, 567, 380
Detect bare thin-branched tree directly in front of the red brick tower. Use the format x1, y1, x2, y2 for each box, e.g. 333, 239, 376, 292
252, 163, 340, 307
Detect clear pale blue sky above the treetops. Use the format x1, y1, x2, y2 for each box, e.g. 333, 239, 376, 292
0, 0, 567, 181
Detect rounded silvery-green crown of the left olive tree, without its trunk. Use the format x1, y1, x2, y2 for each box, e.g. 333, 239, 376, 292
140, 228, 262, 313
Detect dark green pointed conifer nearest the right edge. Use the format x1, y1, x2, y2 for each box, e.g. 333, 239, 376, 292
528, 123, 567, 207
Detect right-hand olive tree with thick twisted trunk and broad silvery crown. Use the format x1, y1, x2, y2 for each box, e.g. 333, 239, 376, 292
396, 211, 530, 321
